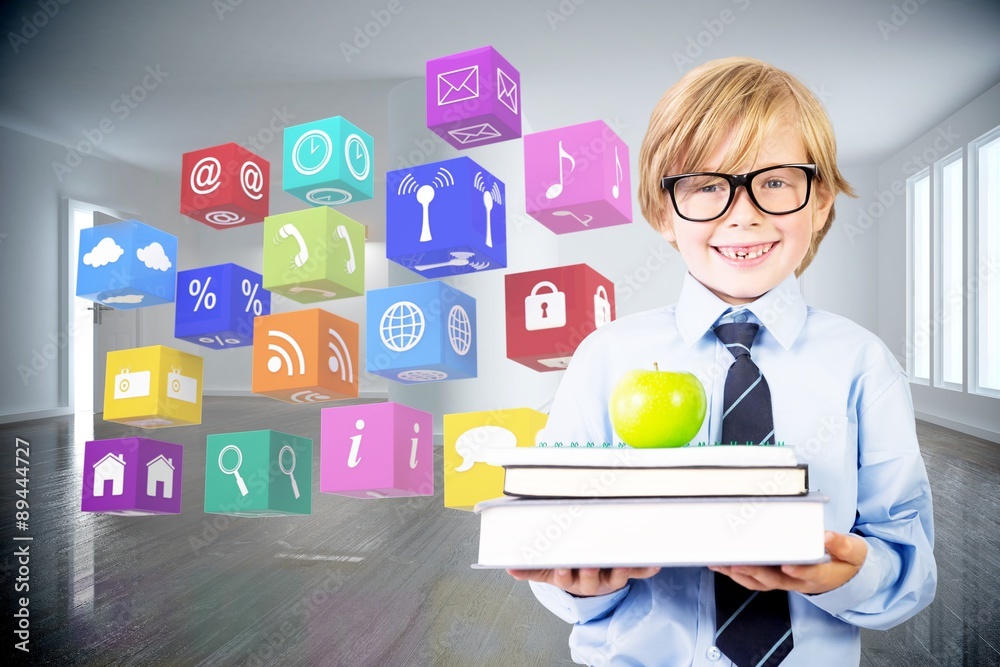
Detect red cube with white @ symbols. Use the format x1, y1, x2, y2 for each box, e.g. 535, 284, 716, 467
181, 143, 271, 229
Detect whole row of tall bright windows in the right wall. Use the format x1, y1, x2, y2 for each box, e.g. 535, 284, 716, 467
906, 122, 1000, 398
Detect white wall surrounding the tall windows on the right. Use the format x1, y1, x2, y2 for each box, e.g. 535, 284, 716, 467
867, 84, 1000, 442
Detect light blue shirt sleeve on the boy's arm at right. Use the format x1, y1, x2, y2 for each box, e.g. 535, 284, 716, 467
806, 368, 937, 629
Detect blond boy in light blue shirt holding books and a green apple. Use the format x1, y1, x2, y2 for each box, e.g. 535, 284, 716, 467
509, 58, 937, 667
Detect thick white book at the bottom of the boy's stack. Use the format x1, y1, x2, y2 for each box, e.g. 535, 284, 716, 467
473, 493, 827, 569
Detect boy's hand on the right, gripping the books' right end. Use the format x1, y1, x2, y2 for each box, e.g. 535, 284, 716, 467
708, 531, 868, 595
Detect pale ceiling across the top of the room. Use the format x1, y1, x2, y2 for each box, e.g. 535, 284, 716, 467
0, 0, 1000, 178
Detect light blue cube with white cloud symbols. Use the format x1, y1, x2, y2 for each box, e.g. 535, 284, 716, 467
76, 220, 177, 310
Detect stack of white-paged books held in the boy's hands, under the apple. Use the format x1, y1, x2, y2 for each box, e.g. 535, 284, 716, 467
473, 445, 827, 569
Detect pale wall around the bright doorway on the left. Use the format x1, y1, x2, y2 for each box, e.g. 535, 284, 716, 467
0, 127, 200, 419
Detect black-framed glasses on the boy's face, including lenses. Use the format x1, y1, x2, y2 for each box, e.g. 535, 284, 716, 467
660, 164, 816, 222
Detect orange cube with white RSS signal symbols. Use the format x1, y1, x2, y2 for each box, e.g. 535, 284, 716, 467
251, 308, 359, 403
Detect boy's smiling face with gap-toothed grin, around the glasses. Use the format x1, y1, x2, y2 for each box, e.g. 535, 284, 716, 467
661, 122, 833, 305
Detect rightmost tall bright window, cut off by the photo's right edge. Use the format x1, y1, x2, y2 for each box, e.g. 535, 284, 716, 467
969, 127, 1000, 397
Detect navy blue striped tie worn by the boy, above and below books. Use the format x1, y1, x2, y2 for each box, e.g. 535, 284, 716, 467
715, 322, 793, 667
